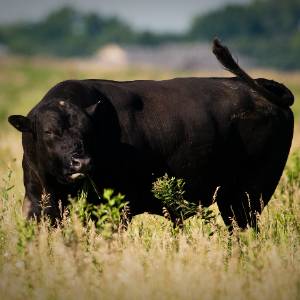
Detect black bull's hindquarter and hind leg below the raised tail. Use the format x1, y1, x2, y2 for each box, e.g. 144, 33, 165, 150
217, 107, 293, 228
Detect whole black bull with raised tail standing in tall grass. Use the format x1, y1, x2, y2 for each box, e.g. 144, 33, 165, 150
9, 41, 293, 228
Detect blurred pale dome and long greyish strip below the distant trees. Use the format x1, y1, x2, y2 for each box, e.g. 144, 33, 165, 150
92, 43, 252, 70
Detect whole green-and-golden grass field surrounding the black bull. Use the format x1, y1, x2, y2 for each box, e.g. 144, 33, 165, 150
0, 59, 300, 300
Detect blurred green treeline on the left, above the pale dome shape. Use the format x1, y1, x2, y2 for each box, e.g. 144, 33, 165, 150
0, 7, 181, 57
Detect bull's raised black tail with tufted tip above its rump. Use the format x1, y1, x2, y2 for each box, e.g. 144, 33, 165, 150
212, 39, 294, 107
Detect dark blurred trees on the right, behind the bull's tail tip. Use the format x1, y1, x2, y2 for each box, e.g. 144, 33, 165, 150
189, 0, 300, 69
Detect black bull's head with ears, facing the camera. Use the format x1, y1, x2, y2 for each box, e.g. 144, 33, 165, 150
8, 100, 98, 184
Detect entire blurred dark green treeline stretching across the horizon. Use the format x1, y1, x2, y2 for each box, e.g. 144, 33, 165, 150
0, 0, 300, 69
